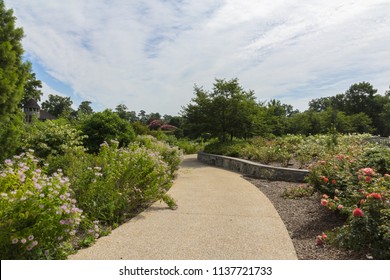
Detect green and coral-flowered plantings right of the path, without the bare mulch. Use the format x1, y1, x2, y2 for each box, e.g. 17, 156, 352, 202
206, 134, 390, 259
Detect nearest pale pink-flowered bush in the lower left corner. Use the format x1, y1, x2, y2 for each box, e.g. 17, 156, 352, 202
0, 153, 82, 260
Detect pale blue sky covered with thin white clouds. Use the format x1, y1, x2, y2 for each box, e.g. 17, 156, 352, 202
4, 0, 390, 115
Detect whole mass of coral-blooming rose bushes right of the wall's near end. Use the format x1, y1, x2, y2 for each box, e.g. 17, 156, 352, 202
308, 142, 390, 259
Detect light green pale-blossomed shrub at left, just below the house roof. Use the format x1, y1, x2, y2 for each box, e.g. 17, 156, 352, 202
23, 120, 85, 159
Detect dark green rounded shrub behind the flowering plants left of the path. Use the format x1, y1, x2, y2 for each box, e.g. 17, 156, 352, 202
81, 110, 135, 153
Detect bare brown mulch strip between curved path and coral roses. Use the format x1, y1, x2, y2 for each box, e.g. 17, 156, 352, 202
245, 177, 366, 260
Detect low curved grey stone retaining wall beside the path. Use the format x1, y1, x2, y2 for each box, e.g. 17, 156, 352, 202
198, 152, 309, 183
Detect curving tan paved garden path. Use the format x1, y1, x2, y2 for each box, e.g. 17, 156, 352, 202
69, 155, 297, 260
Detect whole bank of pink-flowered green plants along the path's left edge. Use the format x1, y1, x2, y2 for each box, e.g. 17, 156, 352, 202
0, 137, 181, 259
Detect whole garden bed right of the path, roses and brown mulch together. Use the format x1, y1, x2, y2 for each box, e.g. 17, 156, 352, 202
206, 134, 390, 259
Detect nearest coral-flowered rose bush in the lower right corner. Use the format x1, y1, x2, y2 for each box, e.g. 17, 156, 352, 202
328, 175, 390, 259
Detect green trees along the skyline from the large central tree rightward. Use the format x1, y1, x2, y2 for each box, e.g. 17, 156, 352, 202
181, 79, 390, 141
